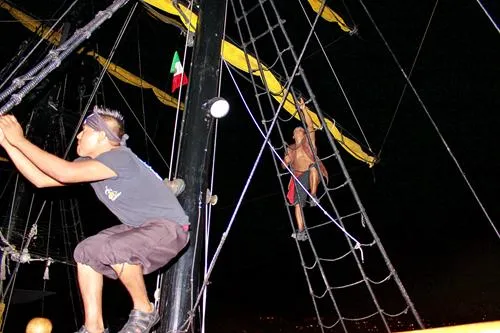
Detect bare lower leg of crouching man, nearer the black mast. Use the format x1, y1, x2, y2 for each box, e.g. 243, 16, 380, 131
112, 264, 154, 312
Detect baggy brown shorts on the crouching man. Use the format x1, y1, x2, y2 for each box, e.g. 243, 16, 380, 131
74, 220, 189, 279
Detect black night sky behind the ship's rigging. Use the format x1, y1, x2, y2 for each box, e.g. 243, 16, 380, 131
0, 0, 500, 330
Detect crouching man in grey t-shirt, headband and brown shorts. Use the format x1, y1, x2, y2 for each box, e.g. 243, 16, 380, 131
0, 107, 189, 333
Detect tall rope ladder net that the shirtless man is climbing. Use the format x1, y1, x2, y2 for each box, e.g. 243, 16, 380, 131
226, 0, 423, 332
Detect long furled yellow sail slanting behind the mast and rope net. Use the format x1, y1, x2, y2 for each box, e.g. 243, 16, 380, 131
144, 0, 376, 167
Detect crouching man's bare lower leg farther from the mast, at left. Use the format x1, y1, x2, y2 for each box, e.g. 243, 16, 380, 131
77, 263, 104, 333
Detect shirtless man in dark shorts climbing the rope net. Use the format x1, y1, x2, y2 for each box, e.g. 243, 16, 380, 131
284, 98, 328, 241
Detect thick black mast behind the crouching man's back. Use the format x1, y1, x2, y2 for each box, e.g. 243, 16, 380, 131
158, 0, 226, 333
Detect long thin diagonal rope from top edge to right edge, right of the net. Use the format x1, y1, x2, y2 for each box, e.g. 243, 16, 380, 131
359, 0, 500, 239
